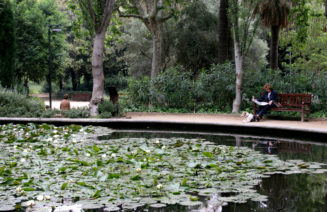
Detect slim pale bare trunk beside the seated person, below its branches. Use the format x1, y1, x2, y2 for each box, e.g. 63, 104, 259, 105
232, 39, 243, 113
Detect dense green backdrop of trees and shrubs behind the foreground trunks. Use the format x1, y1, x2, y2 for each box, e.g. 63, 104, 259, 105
0, 0, 327, 116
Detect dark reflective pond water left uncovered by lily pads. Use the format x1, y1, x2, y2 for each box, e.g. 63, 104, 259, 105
100, 131, 327, 212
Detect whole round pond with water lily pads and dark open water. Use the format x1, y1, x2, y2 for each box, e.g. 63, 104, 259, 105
0, 124, 327, 212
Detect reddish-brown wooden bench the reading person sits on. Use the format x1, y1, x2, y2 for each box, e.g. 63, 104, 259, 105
254, 93, 311, 122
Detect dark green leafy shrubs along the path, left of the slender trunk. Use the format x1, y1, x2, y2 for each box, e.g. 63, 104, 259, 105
124, 64, 235, 112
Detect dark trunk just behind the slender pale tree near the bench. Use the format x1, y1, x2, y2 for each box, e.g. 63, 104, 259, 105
218, 0, 233, 64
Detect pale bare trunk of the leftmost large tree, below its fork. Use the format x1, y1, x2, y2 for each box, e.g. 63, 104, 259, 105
90, 28, 106, 116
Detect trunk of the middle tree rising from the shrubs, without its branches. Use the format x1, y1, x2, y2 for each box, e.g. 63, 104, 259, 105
151, 22, 164, 79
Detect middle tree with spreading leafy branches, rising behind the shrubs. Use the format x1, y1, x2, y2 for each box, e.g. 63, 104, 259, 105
118, 0, 184, 79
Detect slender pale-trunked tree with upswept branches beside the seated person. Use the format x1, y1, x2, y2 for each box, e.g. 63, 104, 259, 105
229, 0, 258, 113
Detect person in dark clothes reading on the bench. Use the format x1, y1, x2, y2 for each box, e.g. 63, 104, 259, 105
251, 83, 278, 121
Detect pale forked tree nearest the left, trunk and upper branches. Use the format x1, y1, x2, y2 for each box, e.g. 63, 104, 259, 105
78, 0, 116, 116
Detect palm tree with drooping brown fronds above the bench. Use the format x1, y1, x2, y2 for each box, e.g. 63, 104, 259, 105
254, 0, 290, 69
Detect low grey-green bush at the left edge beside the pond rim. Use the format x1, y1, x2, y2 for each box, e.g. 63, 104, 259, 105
0, 90, 45, 117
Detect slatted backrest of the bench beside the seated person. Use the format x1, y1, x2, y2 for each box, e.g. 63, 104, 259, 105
278, 93, 311, 107
